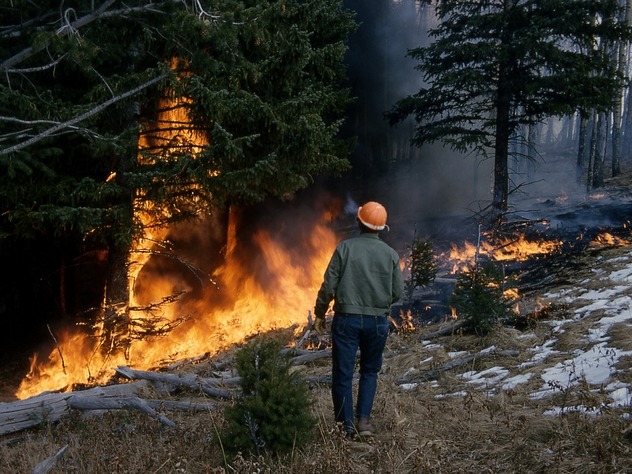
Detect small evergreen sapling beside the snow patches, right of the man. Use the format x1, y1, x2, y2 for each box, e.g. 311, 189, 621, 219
450, 262, 512, 334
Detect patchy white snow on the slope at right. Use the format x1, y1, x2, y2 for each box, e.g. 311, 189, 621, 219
401, 246, 632, 415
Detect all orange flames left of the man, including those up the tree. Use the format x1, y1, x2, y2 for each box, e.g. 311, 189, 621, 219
16, 66, 338, 399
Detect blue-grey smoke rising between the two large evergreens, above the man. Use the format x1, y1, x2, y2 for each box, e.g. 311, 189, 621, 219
345, 0, 490, 244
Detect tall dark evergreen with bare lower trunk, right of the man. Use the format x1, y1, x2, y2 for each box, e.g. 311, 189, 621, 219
387, 0, 629, 221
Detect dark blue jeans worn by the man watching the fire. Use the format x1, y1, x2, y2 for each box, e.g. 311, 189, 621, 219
331, 313, 388, 430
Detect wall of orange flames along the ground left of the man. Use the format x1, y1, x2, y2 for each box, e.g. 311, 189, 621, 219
16, 196, 337, 398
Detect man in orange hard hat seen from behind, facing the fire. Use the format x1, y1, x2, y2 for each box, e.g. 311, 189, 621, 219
314, 201, 404, 438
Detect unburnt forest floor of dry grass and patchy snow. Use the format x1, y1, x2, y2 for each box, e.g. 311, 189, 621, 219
0, 162, 632, 474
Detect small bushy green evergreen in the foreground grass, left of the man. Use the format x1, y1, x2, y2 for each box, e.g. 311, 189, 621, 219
221, 339, 316, 454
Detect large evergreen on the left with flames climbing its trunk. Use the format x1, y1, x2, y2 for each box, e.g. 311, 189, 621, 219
0, 0, 354, 386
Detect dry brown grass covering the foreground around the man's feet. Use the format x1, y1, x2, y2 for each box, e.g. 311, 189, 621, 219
0, 320, 632, 474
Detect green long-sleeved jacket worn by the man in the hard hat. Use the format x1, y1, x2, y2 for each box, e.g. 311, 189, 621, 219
314, 232, 404, 317
